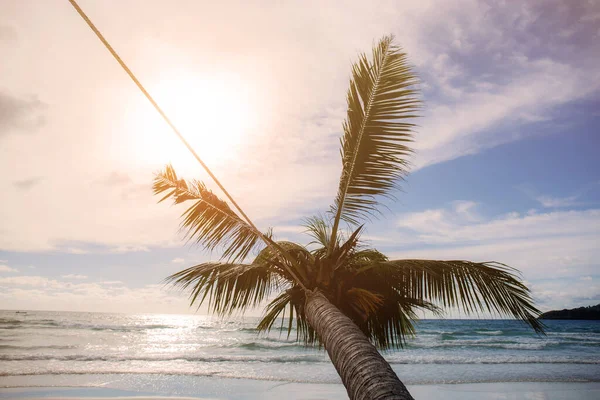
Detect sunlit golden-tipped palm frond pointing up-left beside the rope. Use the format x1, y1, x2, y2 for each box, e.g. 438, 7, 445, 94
152, 165, 261, 262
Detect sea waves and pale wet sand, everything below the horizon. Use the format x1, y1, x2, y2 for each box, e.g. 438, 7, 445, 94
0, 311, 600, 400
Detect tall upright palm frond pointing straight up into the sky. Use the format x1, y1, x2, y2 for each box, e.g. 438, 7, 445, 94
331, 36, 420, 238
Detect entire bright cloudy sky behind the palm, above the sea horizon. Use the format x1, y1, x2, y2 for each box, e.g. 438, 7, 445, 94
0, 0, 600, 313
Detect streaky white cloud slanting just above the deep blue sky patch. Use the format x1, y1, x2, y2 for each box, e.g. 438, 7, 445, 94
416, 59, 600, 167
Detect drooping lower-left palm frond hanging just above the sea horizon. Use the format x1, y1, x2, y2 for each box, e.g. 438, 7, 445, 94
165, 262, 281, 315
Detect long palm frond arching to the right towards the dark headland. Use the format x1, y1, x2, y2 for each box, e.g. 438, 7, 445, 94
380, 260, 544, 333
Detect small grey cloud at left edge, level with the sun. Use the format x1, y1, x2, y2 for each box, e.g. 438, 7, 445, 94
0, 92, 45, 137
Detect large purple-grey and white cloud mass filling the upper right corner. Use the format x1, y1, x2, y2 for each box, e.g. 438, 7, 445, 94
399, 1, 600, 168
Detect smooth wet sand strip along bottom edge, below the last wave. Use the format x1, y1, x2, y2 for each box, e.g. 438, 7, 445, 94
0, 377, 600, 400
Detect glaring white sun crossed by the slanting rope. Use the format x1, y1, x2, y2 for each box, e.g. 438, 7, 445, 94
128, 73, 256, 170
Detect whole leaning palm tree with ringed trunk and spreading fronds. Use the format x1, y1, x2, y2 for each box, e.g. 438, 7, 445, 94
153, 37, 542, 399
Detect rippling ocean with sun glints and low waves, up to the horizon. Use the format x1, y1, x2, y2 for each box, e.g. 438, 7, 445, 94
0, 311, 600, 394
